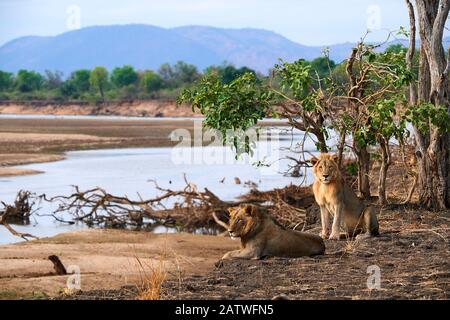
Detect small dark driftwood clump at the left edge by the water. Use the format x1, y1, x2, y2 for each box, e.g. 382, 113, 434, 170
0, 191, 37, 240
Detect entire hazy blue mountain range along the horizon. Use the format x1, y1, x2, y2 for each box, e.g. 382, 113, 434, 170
0, 24, 448, 76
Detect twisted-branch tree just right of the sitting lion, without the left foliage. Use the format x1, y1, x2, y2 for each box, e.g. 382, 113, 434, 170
344, 43, 413, 204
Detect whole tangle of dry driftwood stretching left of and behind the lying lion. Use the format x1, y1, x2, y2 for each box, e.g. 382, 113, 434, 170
40, 177, 316, 233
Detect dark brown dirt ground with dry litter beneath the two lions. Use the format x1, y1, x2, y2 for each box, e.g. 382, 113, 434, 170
51, 207, 450, 299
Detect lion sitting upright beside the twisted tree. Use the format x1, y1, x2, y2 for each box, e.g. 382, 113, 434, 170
310, 153, 379, 240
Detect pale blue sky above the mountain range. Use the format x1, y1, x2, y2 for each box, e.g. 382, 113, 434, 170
0, 0, 440, 45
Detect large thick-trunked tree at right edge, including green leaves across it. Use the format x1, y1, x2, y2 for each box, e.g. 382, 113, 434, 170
405, 0, 450, 209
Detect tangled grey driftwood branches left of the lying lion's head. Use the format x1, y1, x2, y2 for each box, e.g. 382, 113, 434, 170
37, 178, 243, 230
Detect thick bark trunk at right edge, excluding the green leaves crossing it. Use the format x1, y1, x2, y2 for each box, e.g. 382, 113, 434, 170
406, 0, 450, 209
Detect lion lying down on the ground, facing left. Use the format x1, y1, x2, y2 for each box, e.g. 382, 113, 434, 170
217, 204, 325, 259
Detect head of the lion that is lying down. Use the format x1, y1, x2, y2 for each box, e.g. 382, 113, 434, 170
228, 204, 259, 238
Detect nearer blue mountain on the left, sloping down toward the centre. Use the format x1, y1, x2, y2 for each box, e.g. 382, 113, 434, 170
0, 25, 221, 75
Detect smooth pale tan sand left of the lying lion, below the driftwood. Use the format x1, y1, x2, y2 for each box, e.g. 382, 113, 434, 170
0, 229, 236, 299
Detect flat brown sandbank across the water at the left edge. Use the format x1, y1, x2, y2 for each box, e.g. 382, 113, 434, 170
0, 119, 194, 177
